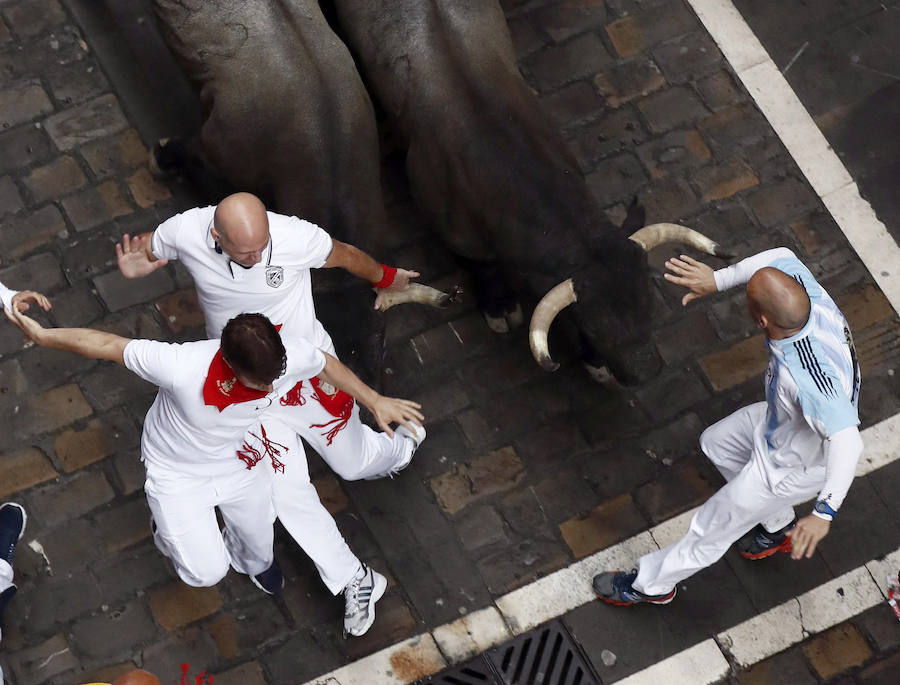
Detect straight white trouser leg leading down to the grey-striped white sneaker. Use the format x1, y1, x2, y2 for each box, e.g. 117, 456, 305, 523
256, 418, 360, 594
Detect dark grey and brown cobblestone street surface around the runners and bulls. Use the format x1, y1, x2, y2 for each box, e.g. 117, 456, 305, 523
0, 0, 900, 685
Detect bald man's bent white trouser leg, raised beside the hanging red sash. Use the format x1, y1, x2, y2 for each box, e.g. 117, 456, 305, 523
266, 374, 411, 480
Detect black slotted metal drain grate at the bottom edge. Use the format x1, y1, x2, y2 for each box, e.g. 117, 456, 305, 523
425, 621, 599, 685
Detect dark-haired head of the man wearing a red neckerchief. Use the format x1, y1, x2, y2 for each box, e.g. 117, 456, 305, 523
220, 314, 287, 392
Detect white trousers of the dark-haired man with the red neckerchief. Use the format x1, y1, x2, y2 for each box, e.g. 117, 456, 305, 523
144, 457, 275, 587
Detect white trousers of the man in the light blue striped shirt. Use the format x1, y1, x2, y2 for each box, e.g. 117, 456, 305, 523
633, 402, 825, 595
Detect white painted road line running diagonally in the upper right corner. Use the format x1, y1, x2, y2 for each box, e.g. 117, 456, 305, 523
687, 0, 900, 312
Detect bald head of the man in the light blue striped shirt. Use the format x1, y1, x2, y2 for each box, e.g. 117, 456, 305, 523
747, 267, 810, 340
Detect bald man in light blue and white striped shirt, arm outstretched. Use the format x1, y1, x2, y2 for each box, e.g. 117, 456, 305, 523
593, 248, 863, 606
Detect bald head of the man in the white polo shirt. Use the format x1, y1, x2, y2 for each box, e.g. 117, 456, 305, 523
210, 193, 269, 267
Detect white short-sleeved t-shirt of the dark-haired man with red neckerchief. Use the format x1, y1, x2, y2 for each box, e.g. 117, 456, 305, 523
124, 339, 325, 476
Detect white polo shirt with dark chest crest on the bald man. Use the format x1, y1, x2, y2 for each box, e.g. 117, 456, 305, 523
152, 207, 334, 354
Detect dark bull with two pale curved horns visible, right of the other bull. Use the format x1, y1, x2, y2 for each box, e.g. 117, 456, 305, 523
335, 0, 719, 385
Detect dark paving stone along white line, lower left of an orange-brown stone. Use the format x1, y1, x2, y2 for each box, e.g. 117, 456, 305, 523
477, 539, 572, 596
